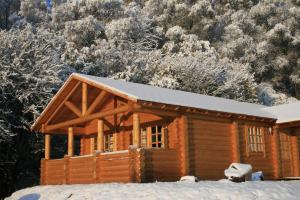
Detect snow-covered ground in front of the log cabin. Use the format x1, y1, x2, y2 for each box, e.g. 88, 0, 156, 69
7, 180, 300, 200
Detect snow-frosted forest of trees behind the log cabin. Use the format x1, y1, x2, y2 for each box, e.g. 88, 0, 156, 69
0, 0, 300, 199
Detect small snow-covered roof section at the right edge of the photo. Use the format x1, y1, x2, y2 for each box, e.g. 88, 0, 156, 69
262, 101, 300, 123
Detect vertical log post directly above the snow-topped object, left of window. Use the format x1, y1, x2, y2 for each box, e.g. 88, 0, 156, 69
231, 121, 241, 163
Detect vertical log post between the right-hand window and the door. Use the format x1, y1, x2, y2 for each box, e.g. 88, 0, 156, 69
271, 126, 282, 179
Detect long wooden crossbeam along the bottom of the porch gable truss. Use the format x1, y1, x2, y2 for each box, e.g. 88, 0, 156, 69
46, 105, 128, 131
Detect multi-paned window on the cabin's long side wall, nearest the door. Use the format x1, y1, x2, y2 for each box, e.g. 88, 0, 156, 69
247, 126, 265, 153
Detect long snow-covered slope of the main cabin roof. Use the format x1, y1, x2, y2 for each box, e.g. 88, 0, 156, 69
73, 73, 276, 119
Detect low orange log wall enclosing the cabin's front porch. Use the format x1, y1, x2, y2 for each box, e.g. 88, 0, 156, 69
41, 148, 180, 185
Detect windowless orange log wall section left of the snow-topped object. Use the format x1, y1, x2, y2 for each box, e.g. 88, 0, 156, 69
188, 117, 233, 180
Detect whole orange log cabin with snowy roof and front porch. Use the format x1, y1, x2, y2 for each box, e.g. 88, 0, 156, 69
32, 73, 300, 185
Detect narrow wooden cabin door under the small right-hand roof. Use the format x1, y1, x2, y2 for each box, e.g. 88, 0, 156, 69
279, 132, 293, 177
